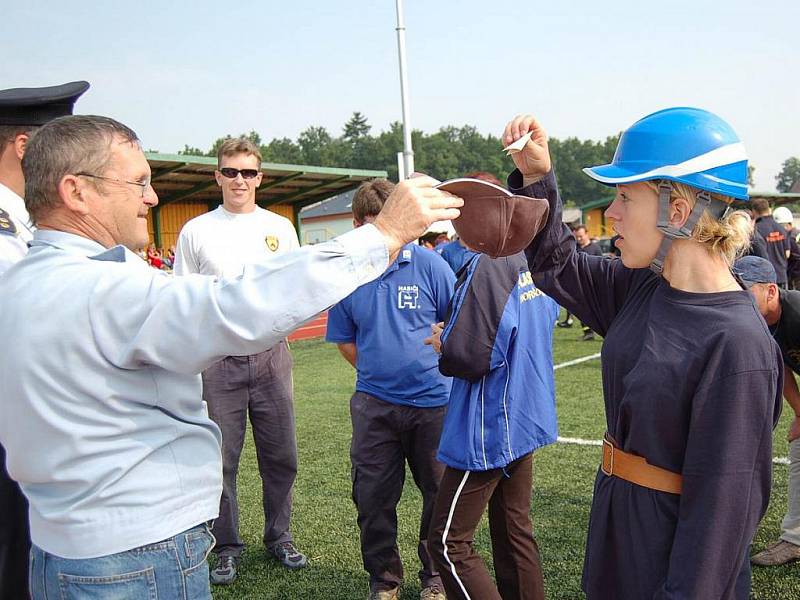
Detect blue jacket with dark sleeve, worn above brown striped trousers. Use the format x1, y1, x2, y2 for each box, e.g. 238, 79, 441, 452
438, 253, 558, 471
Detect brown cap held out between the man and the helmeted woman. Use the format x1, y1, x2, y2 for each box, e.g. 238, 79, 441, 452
436, 179, 550, 258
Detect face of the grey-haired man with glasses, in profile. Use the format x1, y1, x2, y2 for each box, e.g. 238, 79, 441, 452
87, 140, 158, 250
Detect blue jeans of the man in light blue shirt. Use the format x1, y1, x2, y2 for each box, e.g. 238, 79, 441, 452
30, 525, 214, 600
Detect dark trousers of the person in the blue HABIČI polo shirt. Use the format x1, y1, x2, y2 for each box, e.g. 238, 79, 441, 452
350, 392, 445, 590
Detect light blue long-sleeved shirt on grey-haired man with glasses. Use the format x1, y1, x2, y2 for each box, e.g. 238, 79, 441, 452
0, 226, 388, 559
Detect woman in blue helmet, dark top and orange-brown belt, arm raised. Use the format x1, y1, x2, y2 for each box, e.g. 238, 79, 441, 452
503, 108, 782, 600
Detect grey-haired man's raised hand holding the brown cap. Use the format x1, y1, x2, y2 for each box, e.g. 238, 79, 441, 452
374, 176, 464, 260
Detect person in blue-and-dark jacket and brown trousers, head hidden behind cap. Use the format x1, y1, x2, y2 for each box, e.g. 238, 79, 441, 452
428, 252, 558, 600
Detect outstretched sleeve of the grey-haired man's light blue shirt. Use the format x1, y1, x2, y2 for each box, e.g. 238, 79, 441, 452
89, 226, 388, 373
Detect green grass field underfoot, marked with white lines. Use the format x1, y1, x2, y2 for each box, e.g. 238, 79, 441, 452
214, 324, 800, 600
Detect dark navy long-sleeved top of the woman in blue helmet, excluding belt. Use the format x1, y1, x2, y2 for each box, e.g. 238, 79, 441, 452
509, 171, 783, 600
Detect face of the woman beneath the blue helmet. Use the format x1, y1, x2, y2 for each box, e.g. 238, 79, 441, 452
605, 182, 663, 269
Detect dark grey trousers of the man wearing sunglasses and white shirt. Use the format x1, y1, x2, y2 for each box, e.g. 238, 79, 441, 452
203, 341, 297, 557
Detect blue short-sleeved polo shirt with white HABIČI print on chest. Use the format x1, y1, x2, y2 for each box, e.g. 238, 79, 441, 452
325, 244, 455, 407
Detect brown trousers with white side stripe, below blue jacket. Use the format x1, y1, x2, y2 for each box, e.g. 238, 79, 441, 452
428, 453, 544, 600
